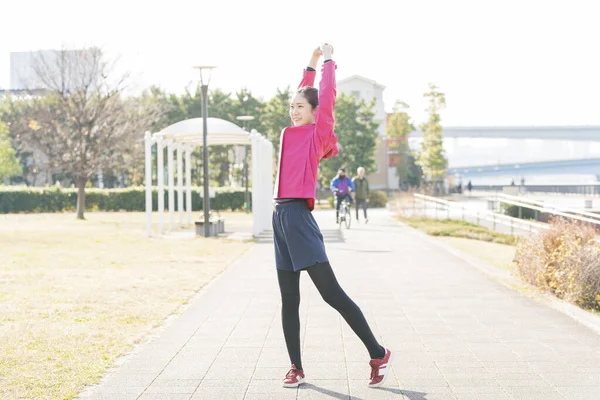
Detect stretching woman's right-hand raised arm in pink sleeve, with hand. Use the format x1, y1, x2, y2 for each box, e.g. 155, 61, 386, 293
315, 44, 337, 147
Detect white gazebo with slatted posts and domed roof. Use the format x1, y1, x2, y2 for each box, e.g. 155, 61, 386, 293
145, 118, 273, 236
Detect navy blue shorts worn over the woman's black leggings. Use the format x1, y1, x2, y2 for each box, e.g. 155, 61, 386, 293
273, 199, 329, 271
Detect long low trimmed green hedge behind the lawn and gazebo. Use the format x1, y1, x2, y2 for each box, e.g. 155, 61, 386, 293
0, 186, 252, 214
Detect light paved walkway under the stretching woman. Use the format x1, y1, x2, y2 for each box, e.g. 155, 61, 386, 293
82, 210, 600, 400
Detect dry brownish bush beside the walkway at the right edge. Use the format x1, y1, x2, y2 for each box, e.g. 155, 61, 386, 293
515, 218, 600, 310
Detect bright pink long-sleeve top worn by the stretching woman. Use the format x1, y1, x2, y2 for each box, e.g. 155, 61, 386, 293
273, 61, 338, 199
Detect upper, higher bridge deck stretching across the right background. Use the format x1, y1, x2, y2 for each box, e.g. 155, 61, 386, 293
410, 125, 600, 141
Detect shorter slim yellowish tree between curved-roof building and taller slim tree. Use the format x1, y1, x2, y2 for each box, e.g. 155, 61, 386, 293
386, 100, 422, 188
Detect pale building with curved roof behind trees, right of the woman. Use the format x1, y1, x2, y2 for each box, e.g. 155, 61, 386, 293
337, 75, 399, 189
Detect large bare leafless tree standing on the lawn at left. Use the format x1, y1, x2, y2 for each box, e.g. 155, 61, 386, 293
16, 48, 164, 219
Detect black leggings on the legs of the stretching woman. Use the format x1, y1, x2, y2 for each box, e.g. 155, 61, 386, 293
277, 262, 385, 370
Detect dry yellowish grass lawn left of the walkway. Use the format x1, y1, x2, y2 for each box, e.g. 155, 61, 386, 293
0, 212, 252, 399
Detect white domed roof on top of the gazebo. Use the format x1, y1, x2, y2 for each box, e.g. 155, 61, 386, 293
155, 118, 251, 146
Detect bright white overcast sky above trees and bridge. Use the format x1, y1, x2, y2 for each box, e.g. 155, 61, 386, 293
0, 0, 600, 126
